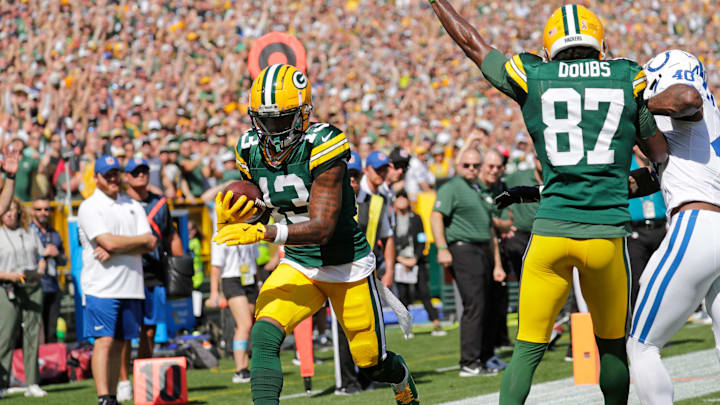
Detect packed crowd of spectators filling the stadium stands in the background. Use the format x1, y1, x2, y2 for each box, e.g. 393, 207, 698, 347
0, 0, 720, 201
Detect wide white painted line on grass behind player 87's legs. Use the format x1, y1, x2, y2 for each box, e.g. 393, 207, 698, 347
443, 350, 720, 405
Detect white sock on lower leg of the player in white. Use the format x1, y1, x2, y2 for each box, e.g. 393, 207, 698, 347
626, 338, 673, 405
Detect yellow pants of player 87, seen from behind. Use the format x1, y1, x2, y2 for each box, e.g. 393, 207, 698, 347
517, 235, 629, 343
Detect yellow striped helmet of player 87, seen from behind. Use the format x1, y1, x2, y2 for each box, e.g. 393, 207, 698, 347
543, 4, 605, 60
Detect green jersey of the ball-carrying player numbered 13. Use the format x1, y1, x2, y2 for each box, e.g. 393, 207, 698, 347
235, 123, 370, 267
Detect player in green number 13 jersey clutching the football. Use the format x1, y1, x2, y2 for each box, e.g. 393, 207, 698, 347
213, 65, 419, 405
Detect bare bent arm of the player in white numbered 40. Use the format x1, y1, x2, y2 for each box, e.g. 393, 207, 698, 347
647, 83, 703, 121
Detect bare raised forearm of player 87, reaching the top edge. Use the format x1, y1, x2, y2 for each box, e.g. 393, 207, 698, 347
430, 0, 492, 67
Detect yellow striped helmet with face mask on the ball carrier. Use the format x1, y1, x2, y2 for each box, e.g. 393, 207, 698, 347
248, 65, 312, 166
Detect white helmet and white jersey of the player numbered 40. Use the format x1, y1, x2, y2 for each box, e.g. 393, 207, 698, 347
645, 50, 720, 216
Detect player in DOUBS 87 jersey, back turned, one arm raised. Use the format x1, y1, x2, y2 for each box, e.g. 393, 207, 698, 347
430, 0, 666, 404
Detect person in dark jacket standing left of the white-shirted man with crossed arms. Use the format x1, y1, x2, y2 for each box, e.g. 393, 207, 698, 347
31, 198, 67, 343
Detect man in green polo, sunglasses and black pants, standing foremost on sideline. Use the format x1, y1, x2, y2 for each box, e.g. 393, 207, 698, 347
430, 149, 505, 377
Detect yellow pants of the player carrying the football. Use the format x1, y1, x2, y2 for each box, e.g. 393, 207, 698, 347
255, 263, 385, 367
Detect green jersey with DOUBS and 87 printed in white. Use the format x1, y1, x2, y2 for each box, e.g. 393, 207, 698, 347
482, 50, 655, 232
